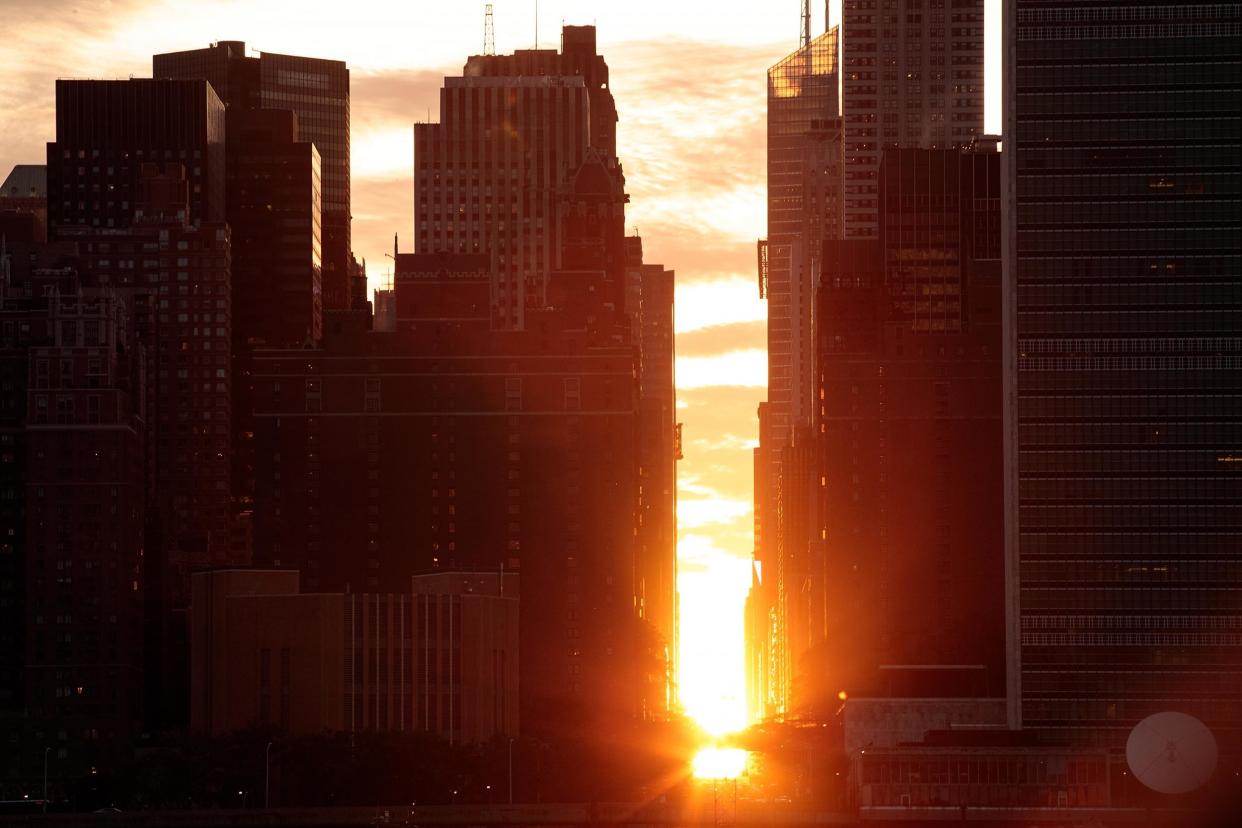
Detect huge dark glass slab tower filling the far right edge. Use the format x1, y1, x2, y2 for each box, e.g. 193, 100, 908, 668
1004, 0, 1242, 761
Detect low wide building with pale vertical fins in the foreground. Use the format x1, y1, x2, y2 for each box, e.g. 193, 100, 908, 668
190, 570, 519, 744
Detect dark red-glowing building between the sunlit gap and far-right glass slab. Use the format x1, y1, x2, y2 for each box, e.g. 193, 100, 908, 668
804, 142, 1005, 715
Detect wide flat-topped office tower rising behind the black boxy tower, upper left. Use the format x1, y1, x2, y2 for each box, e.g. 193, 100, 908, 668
152, 41, 352, 309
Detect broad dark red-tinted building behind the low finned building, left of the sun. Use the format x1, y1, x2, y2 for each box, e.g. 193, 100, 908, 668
255, 254, 638, 730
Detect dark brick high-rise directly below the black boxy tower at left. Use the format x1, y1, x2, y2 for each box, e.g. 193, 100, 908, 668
58, 163, 234, 722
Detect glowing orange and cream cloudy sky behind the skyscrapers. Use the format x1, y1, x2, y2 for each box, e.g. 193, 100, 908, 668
0, 0, 999, 724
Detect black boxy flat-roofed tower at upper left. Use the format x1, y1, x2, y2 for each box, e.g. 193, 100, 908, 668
47, 78, 225, 237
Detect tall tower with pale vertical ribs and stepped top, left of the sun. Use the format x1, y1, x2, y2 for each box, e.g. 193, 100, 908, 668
414, 26, 623, 328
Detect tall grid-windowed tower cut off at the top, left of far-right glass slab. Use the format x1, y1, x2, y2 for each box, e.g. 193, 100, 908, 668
841, 0, 984, 238
